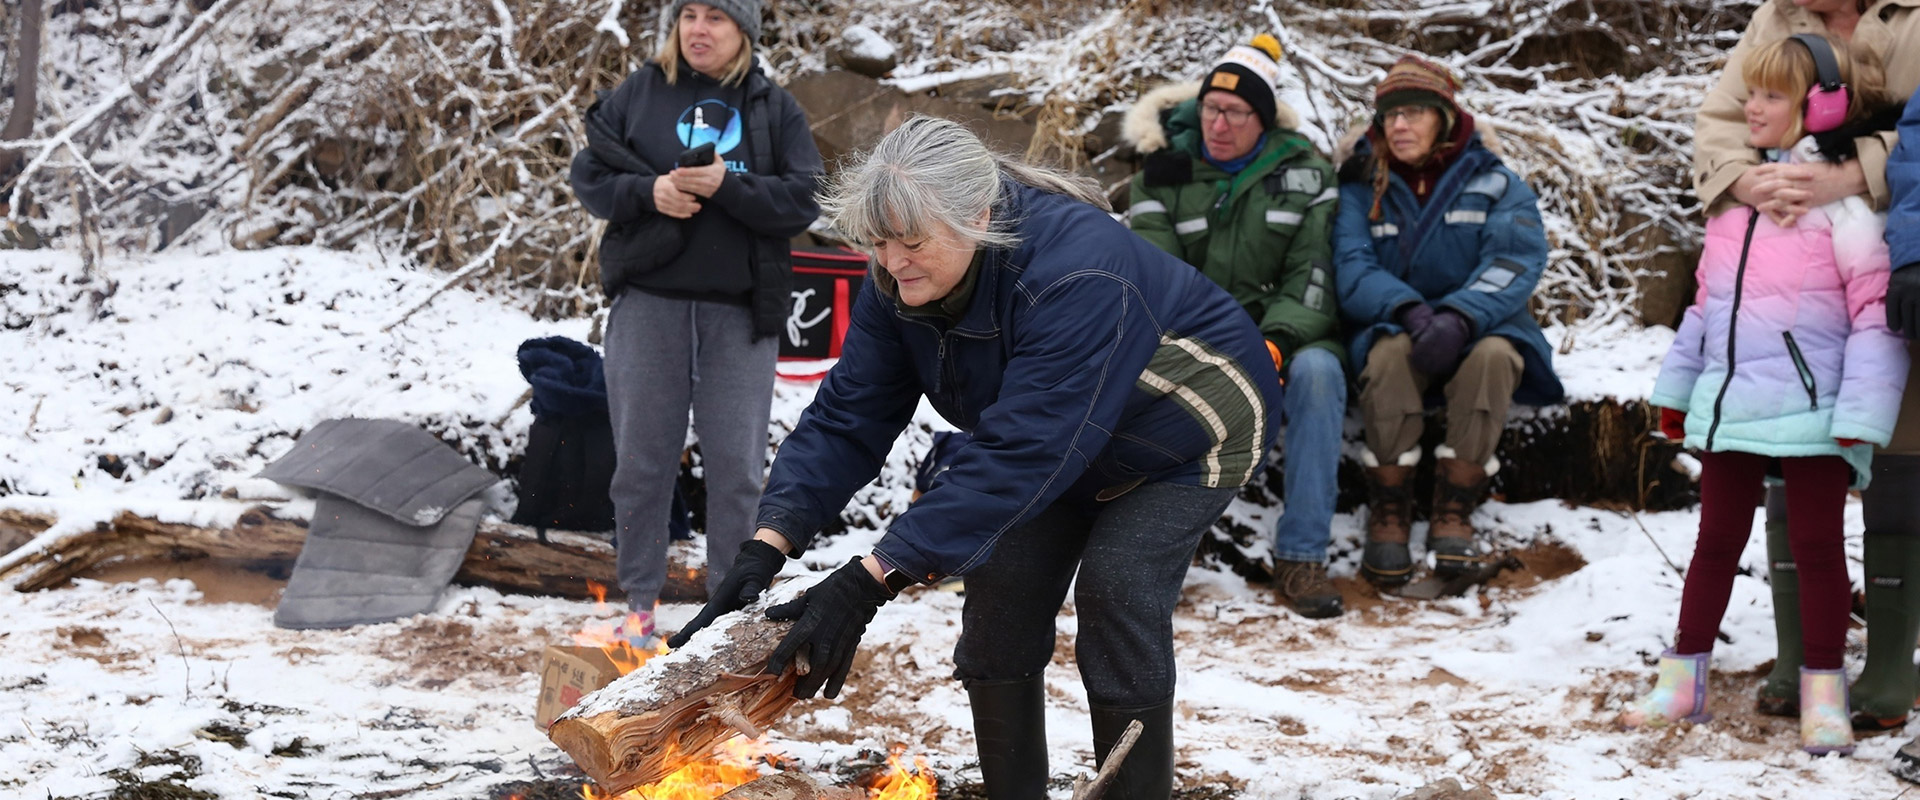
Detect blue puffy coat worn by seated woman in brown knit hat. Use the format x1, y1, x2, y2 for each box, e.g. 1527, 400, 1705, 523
1332, 134, 1567, 405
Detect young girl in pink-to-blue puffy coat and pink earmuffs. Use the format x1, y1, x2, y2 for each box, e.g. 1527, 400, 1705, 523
1620, 36, 1907, 754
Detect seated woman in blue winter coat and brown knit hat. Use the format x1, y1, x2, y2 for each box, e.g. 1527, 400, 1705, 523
1332, 56, 1565, 585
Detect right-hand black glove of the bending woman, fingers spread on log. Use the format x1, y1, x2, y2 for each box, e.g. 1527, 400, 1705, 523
766, 558, 893, 700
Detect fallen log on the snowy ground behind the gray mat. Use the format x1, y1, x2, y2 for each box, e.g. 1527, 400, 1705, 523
0, 506, 707, 602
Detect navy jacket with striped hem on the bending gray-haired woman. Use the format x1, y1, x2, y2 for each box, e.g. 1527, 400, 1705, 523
758, 182, 1279, 581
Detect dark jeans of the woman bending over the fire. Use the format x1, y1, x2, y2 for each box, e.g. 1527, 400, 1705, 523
954, 483, 1235, 708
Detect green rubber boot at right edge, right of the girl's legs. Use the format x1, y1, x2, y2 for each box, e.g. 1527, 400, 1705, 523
1851, 455, 1920, 733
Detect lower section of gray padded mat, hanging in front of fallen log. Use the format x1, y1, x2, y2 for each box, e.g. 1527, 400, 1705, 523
273, 495, 484, 627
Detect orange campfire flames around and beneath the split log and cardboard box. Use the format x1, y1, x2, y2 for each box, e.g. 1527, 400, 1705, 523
572, 581, 939, 800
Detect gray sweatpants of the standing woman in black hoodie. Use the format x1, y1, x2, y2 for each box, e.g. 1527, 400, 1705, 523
607, 290, 780, 612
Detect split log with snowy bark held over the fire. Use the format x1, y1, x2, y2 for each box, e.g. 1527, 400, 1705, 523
547, 593, 799, 794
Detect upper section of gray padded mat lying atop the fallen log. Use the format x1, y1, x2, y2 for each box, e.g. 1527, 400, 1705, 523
259, 420, 499, 526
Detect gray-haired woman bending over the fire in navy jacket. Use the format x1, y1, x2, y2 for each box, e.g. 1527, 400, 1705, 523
672, 117, 1281, 800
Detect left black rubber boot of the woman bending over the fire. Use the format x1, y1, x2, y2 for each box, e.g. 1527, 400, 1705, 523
966, 675, 1046, 800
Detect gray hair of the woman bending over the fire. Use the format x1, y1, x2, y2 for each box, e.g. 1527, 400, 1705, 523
820, 115, 1112, 257
